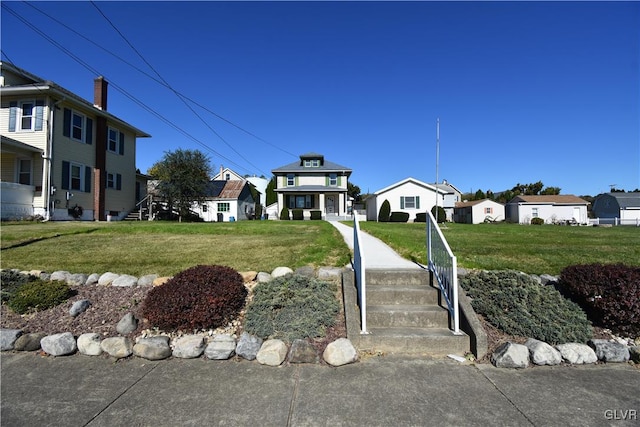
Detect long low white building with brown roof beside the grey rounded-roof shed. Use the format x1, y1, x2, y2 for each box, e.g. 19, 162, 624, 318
505, 195, 589, 224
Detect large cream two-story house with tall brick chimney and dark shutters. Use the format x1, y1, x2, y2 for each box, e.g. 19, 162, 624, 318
0, 62, 150, 220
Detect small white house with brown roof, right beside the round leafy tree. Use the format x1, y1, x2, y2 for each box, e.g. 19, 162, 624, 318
193, 179, 256, 222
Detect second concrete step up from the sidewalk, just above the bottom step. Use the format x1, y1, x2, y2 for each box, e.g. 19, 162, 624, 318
367, 304, 449, 328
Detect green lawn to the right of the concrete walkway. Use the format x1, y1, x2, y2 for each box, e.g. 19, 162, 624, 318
360, 222, 640, 275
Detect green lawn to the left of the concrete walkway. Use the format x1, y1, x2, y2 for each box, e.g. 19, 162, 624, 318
0, 221, 350, 276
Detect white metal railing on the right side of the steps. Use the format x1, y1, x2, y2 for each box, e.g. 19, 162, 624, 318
427, 211, 462, 335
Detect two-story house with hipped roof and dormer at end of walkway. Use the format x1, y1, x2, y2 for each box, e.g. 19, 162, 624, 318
271, 153, 352, 219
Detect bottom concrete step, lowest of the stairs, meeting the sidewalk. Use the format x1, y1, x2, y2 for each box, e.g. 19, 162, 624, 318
357, 328, 470, 356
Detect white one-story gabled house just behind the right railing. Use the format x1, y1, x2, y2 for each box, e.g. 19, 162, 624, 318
367, 177, 447, 221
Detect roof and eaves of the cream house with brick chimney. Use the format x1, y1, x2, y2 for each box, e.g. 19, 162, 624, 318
0, 61, 151, 138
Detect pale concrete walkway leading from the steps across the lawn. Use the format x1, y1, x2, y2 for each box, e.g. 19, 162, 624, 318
329, 221, 422, 270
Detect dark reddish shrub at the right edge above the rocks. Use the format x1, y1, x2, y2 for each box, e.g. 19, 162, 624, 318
560, 263, 640, 337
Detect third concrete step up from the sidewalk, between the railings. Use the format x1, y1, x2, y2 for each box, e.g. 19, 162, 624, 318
367, 285, 439, 306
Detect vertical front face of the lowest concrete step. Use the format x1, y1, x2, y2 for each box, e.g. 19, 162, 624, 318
357, 335, 470, 356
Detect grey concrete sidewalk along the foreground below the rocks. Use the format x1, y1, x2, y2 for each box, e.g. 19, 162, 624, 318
0, 353, 640, 427
